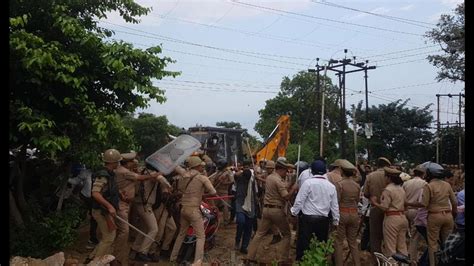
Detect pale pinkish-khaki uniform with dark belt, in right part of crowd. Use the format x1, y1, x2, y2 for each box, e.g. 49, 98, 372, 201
380, 183, 408, 257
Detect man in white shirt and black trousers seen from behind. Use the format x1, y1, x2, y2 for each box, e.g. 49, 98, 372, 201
291, 160, 339, 261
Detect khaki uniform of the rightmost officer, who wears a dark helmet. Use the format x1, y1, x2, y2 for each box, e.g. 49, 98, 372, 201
422, 179, 457, 266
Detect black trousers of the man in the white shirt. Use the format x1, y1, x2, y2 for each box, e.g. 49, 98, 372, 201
296, 214, 329, 261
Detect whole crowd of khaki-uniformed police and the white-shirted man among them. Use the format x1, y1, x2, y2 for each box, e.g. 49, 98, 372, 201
69, 149, 465, 266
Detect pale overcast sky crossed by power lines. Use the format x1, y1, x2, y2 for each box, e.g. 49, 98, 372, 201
100, 0, 464, 140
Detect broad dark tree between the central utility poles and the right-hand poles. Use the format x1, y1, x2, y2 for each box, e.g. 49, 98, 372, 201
356, 100, 434, 163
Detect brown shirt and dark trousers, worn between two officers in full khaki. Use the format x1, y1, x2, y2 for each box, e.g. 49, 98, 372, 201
364, 168, 389, 253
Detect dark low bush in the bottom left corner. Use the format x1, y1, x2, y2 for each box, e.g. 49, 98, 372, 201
10, 201, 86, 258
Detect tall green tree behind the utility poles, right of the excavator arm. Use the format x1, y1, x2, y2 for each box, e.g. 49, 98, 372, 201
255, 71, 340, 161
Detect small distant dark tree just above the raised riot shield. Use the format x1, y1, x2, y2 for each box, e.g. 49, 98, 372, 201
124, 113, 180, 158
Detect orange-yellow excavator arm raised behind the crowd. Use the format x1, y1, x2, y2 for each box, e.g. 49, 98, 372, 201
256, 115, 290, 163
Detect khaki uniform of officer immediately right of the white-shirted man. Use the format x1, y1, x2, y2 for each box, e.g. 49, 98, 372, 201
335, 177, 360, 266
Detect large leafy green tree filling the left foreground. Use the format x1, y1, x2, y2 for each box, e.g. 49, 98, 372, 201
9, 0, 178, 254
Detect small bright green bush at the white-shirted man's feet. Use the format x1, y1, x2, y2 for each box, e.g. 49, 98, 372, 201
298, 235, 334, 266
